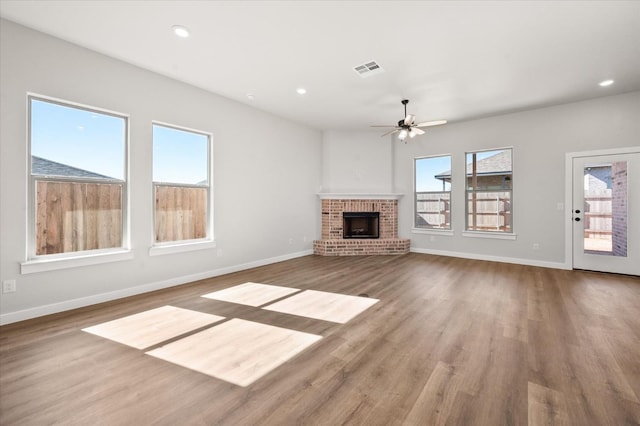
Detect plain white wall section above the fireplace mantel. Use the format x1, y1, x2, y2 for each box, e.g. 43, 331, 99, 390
322, 130, 393, 193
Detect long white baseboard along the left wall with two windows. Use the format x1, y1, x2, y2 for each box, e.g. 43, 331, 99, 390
0, 250, 313, 325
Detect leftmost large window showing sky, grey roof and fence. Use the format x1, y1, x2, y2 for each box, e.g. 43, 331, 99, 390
28, 96, 128, 259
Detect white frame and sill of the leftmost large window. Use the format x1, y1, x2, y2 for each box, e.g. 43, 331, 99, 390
20, 92, 133, 274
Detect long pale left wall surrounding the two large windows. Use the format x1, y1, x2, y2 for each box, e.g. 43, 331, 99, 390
0, 20, 322, 322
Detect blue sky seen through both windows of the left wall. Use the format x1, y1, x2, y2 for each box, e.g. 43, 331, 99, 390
31, 99, 208, 184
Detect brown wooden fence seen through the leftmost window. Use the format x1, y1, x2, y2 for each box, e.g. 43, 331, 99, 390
35, 180, 122, 255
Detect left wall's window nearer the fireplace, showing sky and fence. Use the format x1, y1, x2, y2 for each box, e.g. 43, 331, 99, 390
153, 123, 211, 244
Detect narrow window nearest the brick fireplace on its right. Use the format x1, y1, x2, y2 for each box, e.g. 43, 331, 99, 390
414, 155, 451, 230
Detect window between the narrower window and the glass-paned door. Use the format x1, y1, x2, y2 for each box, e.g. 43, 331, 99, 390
466, 148, 513, 233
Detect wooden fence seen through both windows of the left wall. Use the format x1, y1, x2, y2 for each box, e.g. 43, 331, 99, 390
35, 180, 207, 255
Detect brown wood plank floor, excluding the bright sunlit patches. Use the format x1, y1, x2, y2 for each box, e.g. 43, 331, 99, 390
0, 253, 640, 426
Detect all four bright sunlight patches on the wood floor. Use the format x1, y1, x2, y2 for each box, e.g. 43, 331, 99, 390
83, 282, 379, 386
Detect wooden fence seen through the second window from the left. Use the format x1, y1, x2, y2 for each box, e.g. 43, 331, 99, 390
155, 185, 207, 243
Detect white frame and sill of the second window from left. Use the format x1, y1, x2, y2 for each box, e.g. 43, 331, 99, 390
149, 120, 216, 256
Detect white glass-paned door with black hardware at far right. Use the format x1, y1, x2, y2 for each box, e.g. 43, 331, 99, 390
571, 148, 640, 275
